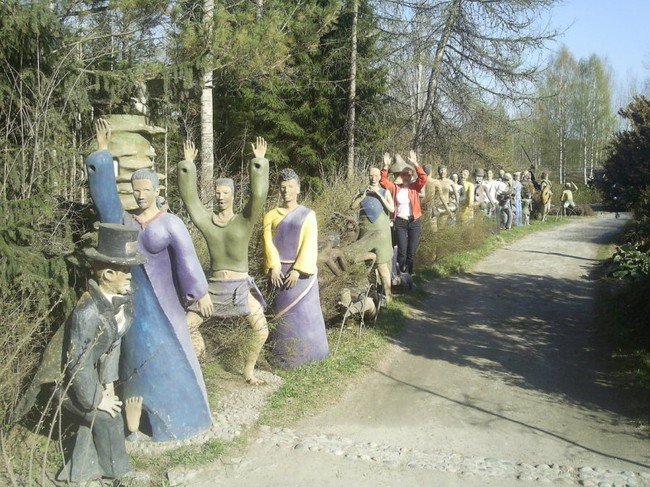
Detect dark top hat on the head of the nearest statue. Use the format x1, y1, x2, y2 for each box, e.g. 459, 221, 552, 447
85, 223, 147, 265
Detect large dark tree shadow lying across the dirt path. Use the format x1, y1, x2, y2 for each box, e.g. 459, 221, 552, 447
395, 269, 634, 417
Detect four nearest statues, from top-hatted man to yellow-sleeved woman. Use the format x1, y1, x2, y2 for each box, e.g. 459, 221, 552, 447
19, 119, 329, 482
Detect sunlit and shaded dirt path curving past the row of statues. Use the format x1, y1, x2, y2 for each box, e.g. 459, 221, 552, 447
175, 216, 650, 486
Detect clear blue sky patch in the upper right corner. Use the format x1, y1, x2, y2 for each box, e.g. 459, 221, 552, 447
551, 0, 650, 89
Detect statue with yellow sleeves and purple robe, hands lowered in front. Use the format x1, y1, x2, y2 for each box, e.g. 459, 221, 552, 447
263, 169, 329, 367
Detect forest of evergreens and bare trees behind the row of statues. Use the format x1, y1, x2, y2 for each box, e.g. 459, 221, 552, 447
0, 0, 647, 478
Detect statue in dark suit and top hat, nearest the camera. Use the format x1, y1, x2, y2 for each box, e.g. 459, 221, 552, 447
18, 224, 146, 482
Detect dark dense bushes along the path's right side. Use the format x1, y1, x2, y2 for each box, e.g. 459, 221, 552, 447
595, 96, 650, 397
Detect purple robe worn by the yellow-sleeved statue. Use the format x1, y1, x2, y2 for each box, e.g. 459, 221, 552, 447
273, 205, 329, 367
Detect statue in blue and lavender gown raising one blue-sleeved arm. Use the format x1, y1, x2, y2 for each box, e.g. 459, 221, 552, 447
86, 120, 212, 441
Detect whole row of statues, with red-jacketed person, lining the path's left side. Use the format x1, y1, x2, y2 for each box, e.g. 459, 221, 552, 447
19, 108, 574, 482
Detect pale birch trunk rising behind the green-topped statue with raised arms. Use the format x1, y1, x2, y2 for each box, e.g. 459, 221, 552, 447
200, 0, 214, 207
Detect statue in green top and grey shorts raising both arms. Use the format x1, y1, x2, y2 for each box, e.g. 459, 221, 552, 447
178, 137, 269, 385
